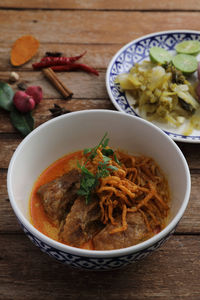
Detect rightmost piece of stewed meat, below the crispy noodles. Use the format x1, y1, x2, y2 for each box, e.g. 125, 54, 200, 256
93, 212, 149, 250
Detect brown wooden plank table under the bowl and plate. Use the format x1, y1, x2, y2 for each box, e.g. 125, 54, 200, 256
0, 0, 200, 300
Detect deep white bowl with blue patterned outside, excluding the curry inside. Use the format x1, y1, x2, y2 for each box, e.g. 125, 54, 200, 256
7, 110, 190, 270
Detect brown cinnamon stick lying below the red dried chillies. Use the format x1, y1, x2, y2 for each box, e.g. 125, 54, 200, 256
42, 68, 73, 99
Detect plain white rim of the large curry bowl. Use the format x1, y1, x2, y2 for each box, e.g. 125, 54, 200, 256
7, 109, 191, 258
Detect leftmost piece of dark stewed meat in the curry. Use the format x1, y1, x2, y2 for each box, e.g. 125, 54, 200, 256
37, 169, 80, 222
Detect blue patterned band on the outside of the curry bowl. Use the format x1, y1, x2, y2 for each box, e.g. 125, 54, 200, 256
20, 223, 174, 270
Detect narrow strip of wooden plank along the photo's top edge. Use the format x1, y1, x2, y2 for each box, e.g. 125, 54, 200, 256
1, 0, 200, 10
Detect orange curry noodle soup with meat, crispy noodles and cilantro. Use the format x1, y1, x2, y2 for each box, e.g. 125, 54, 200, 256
30, 138, 170, 250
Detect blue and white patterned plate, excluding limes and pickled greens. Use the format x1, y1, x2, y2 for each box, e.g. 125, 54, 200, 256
106, 30, 200, 143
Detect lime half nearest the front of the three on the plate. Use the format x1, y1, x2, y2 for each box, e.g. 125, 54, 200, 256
172, 54, 198, 74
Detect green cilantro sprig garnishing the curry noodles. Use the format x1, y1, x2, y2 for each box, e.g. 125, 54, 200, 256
77, 132, 119, 204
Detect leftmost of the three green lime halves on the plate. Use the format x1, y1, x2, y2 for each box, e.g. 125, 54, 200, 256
149, 47, 172, 65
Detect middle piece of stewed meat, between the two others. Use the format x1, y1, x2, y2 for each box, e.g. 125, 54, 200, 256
60, 197, 104, 247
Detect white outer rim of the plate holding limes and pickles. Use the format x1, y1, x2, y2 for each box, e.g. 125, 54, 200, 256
105, 29, 200, 143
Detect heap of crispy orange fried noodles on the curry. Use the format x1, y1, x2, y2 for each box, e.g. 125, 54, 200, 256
83, 147, 170, 234
